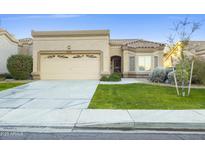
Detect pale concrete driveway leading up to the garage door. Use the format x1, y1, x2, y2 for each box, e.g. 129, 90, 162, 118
0, 80, 99, 109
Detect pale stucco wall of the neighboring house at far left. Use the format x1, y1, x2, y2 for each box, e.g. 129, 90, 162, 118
0, 34, 18, 73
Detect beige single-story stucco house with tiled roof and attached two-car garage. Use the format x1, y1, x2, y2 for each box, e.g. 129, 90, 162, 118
32, 30, 164, 79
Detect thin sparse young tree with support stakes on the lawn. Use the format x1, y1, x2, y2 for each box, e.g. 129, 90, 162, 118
167, 18, 201, 97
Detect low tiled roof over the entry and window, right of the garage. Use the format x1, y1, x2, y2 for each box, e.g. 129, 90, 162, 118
110, 39, 165, 49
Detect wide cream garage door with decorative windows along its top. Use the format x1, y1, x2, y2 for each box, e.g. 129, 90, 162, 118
40, 54, 100, 80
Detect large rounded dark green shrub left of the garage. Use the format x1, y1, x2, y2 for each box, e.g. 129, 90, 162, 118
7, 55, 33, 80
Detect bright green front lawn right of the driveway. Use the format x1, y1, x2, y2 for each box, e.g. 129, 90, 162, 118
89, 84, 205, 109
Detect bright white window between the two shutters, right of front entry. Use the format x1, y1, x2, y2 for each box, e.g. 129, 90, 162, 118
138, 56, 152, 71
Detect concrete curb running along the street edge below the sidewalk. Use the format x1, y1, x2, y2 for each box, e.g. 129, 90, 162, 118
0, 123, 205, 132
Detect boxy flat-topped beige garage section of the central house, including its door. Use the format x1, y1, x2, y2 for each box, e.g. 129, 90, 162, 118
32, 30, 110, 80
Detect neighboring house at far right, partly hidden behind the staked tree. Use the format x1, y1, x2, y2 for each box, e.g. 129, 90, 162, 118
163, 41, 205, 67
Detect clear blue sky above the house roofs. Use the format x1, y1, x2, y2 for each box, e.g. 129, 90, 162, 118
0, 14, 205, 42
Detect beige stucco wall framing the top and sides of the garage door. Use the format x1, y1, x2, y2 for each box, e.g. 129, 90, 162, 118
33, 36, 110, 78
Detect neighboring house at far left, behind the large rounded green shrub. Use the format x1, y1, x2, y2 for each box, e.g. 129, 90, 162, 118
0, 29, 32, 74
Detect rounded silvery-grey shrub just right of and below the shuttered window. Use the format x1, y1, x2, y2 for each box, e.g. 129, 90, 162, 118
150, 67, 166, 83
